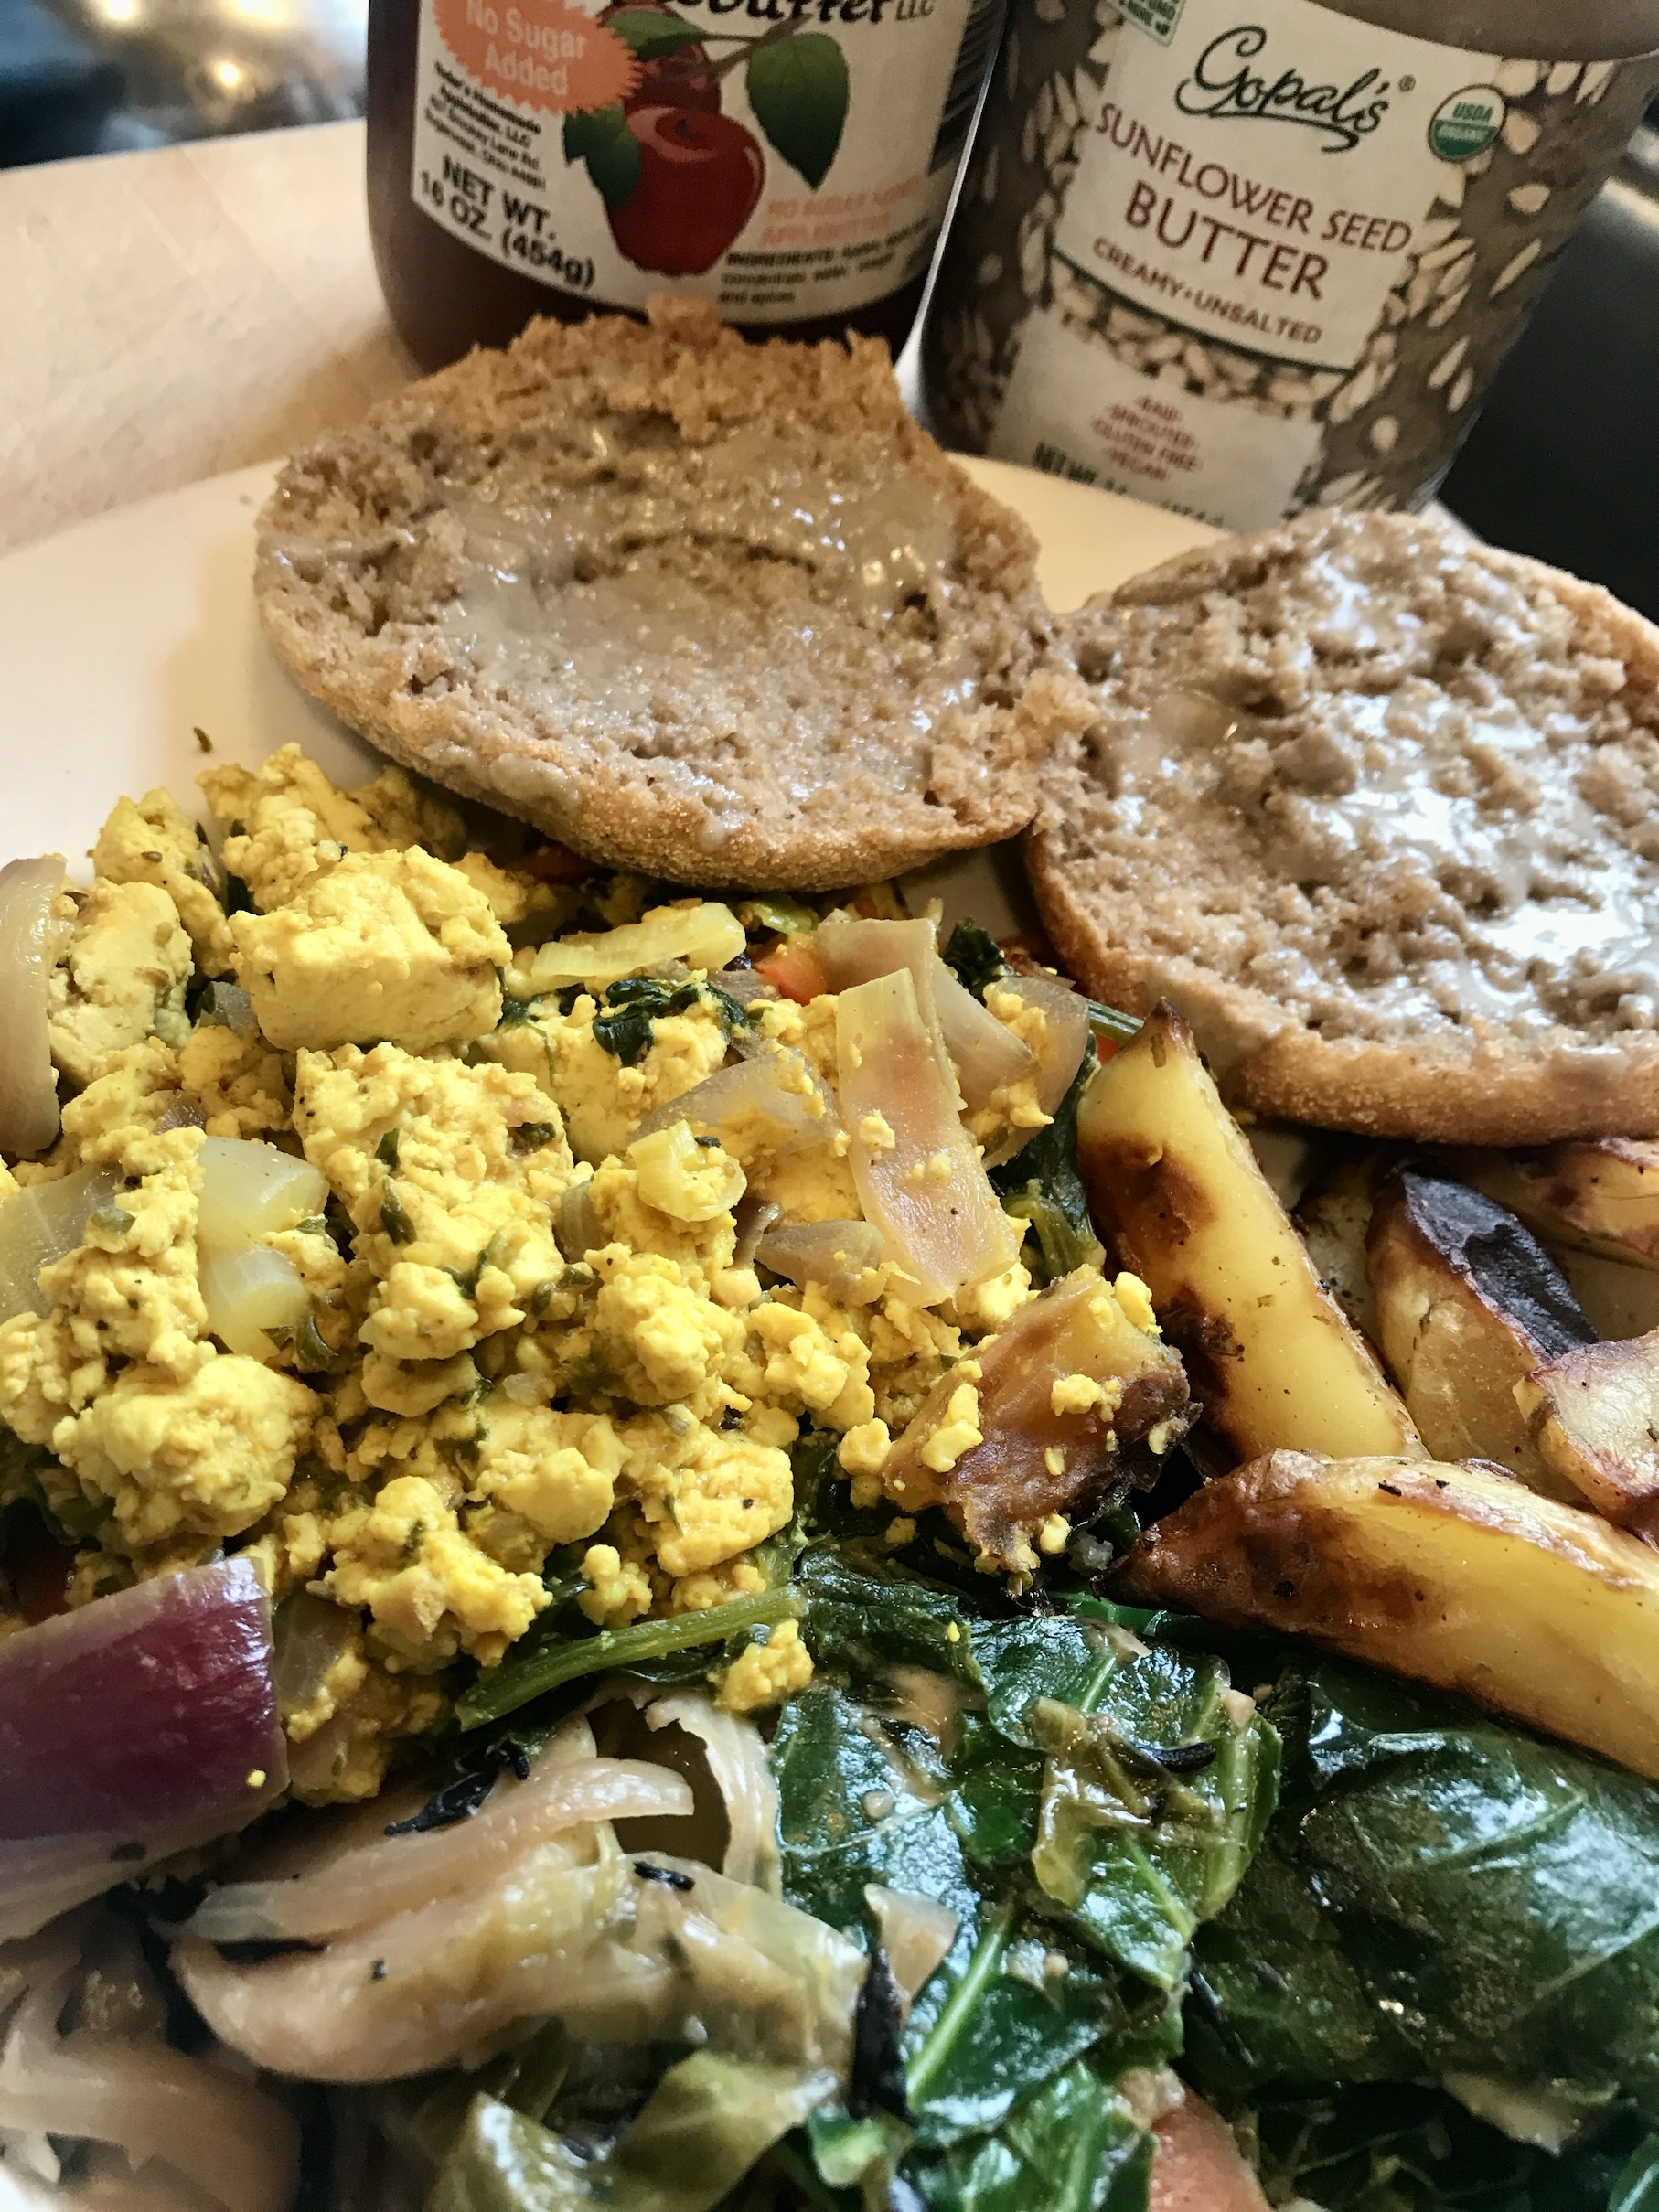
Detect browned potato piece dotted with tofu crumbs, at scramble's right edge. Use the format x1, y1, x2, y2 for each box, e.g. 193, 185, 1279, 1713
883, 1267, 1193, 1573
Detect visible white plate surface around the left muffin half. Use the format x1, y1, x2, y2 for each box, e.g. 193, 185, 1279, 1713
0, 460, 1216, 898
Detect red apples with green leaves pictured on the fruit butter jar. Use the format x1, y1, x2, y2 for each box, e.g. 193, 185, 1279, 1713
564, 0, 850, 276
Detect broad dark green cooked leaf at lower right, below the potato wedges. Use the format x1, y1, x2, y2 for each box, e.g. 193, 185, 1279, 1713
1188, 1662, 1659, 2128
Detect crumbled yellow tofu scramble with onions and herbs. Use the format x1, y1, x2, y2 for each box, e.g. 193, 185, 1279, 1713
0, 745, 1182, 1802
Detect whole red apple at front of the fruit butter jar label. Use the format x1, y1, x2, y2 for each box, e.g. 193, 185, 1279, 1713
606, 106, 765, 276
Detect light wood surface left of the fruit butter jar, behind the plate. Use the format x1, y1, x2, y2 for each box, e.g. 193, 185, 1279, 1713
0, 123, 416, 550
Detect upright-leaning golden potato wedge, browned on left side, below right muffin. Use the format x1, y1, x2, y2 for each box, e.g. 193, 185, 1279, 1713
1077, 1004, 1424, 1460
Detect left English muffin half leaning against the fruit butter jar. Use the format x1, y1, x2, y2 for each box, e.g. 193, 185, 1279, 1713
257, 299, 1077, 889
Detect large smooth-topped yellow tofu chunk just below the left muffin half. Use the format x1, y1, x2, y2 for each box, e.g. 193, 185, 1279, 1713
230, 845, 511, 1053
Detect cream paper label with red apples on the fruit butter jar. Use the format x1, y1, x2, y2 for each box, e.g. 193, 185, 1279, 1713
409, 0, 1002, 323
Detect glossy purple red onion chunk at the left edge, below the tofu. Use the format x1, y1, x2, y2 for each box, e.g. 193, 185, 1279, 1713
0, 1559, 287, 1938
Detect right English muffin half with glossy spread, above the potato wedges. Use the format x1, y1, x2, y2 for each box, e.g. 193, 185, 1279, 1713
1029, 511, 1659, 1144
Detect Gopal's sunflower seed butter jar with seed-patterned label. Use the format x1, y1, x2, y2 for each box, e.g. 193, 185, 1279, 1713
923, 0, 1659, 529
